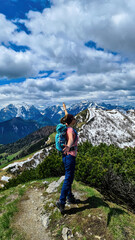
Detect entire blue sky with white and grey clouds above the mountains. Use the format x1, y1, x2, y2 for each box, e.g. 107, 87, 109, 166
0, 0, 135, 107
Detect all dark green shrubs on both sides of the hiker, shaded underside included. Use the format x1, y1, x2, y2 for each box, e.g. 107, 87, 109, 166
2, 141, 135, 211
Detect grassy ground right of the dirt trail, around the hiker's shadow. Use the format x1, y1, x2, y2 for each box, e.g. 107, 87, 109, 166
45, 181, 135, 240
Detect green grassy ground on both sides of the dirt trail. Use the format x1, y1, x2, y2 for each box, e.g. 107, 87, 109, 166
0, 177, 135, 240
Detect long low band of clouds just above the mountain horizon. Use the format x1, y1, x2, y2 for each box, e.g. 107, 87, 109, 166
0, 62, 135, 105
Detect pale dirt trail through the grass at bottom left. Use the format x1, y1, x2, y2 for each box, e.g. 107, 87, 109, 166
12, 188, 52, 240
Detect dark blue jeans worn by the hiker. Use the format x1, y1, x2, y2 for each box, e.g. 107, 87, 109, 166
60, 154, 76, 204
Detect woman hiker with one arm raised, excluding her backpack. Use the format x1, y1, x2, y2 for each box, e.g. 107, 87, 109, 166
56, 103, 78, 213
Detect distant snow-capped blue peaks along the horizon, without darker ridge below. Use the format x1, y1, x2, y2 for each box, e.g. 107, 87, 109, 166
0, 100, 133, 124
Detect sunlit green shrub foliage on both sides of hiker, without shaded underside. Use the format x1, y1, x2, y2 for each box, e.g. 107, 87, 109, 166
2, 141, 135, 187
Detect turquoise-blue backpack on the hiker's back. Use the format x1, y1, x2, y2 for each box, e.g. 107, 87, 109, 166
55, 123, 77, 152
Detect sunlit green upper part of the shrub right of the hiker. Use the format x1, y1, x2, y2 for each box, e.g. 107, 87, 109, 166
76, 141, 135, 186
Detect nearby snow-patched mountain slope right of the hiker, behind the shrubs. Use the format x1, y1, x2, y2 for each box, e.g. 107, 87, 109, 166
77, 107, 135, 148
